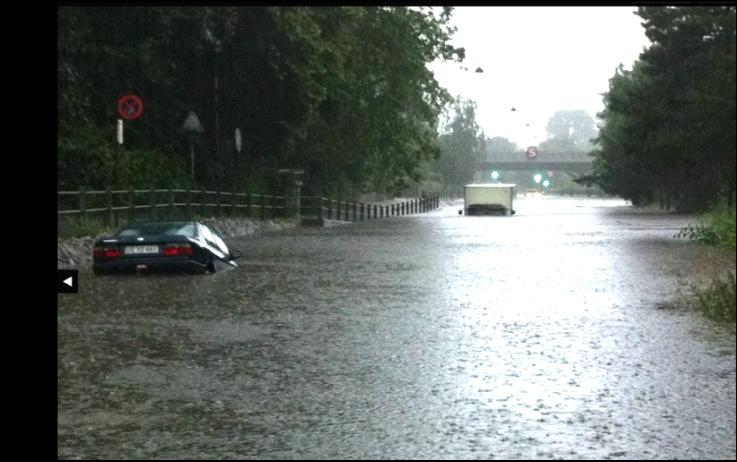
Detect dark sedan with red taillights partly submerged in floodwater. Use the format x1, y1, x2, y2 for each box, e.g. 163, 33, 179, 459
92, 221, 241, 274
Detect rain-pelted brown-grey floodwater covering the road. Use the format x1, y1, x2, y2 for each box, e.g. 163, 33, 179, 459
58, 198, 735, 459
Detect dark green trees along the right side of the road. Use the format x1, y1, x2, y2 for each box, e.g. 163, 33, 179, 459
585, 6, 737, 211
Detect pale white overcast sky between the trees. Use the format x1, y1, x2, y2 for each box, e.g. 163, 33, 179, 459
428, 7, 650, 148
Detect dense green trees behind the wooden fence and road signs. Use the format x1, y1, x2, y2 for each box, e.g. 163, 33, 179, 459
58, 7, 463, 195
